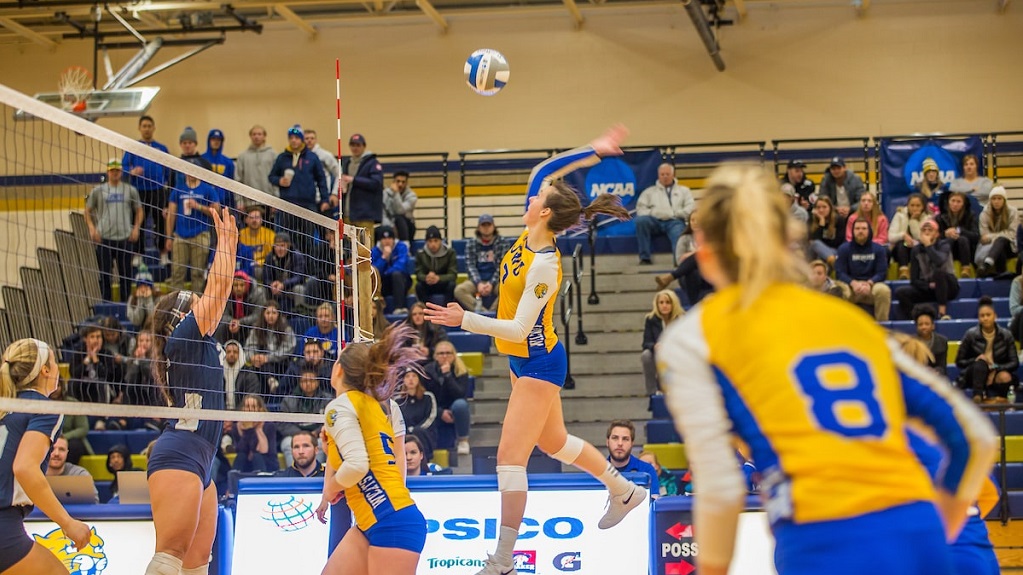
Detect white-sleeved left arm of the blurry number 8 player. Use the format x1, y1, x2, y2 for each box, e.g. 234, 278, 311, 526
658, 308, 746, 566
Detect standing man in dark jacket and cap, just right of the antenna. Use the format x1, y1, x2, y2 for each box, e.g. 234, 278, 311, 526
338, 134, 384, 237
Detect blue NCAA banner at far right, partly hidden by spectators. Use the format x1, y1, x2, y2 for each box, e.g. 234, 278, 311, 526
880, 136, 984, 217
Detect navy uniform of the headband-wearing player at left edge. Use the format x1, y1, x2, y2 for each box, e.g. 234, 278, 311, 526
0, 390, 63, 573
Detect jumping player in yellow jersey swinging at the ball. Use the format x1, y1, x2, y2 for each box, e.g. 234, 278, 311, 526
427, 126, 647, 575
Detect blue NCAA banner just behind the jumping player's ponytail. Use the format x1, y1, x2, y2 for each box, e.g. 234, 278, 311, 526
565, 148, 664, 235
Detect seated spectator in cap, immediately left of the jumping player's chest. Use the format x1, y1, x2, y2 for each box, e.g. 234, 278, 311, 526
454, 214, 512, 312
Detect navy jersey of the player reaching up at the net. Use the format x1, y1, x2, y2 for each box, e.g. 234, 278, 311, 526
164, 312, 224, 446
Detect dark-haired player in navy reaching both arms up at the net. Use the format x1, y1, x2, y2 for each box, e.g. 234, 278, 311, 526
145, 208, 238, 575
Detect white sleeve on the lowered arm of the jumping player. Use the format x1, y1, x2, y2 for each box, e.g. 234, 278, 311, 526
461, 252, 558, 342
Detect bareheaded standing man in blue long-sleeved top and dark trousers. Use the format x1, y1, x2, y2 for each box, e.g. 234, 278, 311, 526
121, 116, 172, 255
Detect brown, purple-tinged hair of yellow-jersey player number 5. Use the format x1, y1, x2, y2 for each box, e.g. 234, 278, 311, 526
338, 325, 422, 401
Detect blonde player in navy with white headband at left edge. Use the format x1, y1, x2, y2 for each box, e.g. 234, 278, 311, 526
0, 339, 92, 575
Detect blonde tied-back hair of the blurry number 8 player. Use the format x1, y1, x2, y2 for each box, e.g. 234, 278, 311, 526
700, 164, 808, 307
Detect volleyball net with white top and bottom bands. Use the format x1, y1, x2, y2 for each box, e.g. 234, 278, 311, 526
0, 85, 374, 429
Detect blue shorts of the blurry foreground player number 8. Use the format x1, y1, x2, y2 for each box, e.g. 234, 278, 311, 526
772, 501, 954, 575
